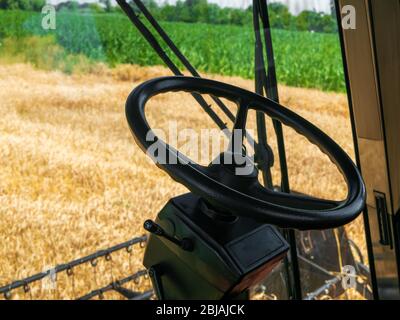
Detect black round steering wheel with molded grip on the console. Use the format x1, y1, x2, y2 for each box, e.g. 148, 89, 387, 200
126, 76, 365, 230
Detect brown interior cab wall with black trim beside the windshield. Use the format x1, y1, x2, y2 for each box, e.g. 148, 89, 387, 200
338, 0, 400, 299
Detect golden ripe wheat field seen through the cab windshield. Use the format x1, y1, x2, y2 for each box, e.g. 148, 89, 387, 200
0, 64, 366, 299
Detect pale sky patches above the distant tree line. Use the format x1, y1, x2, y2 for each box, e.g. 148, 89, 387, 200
47, 0, 330, 14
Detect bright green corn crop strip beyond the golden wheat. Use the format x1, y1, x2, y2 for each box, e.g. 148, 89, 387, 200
0, 11, 345, 91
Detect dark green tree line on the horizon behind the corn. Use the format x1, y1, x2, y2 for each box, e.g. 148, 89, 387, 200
0, 0, 336, 33
